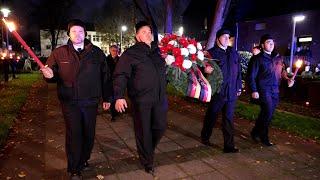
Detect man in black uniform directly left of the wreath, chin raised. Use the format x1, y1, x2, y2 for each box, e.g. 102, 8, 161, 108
113, 21, 168, 174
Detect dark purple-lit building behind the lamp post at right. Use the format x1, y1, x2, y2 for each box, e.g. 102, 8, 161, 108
238, 11, 320, 65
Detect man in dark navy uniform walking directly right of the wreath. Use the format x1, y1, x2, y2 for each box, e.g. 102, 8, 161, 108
201, 29, 241, 153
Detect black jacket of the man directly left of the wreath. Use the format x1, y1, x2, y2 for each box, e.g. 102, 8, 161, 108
113, 42, 166, 103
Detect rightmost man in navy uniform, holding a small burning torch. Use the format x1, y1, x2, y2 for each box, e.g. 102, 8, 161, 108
248, 34, 292, 146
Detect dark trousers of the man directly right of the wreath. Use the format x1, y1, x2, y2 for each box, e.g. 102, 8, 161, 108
201, 96, 236, 148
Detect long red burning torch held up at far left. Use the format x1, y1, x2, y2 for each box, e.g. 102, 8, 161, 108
2, 18, 45, 69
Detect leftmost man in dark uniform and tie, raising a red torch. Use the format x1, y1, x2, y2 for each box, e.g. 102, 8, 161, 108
41, 19, 112, 179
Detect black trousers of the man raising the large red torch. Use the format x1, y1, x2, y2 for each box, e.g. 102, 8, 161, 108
61, 101, 98, 173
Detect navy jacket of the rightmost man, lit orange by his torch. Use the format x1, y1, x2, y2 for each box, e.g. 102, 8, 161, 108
248, 52, 283, 93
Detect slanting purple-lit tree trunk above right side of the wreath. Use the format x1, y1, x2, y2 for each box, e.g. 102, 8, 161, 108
206, 0, 230, 50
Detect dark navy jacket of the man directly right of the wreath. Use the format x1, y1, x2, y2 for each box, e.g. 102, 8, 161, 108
208, 45, 242, 101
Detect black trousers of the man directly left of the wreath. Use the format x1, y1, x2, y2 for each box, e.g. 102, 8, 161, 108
132, 100, 168, 167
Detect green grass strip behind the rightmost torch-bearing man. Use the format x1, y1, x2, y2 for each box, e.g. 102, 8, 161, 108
236, 101, 320, 141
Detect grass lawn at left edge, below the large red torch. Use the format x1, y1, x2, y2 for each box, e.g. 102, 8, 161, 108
0, 73, 42, 146
